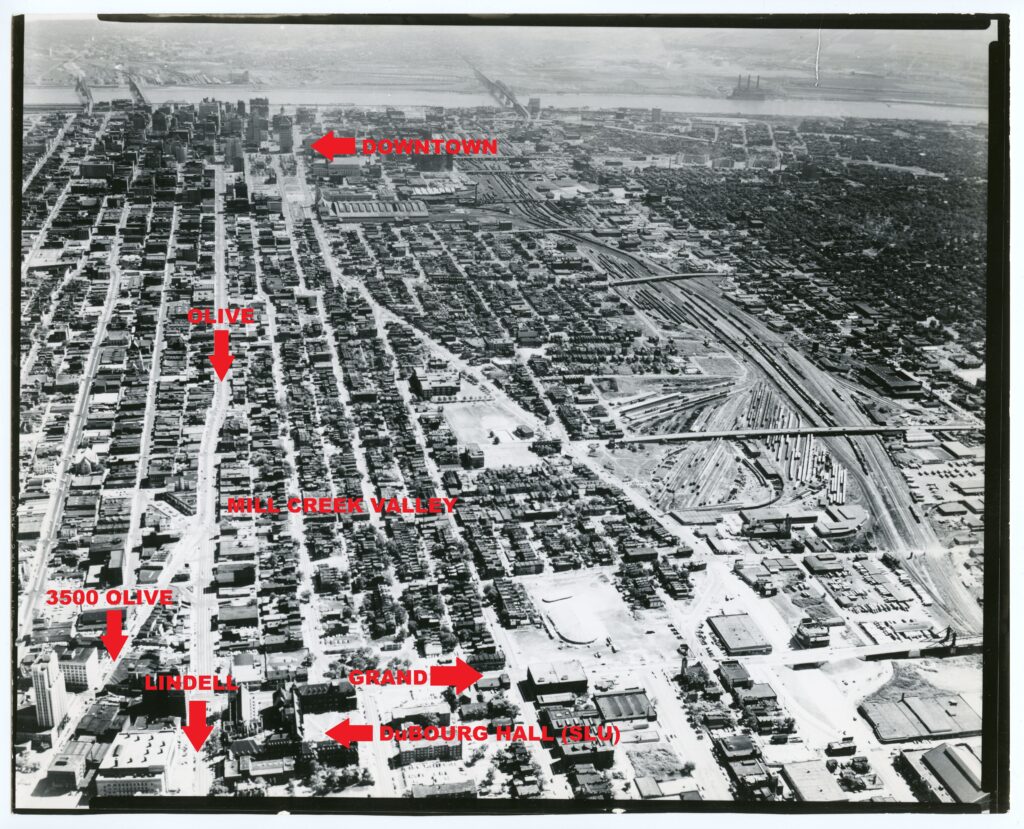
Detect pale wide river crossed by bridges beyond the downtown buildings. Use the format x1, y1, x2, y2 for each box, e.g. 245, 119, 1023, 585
25, 85, 988, 124
